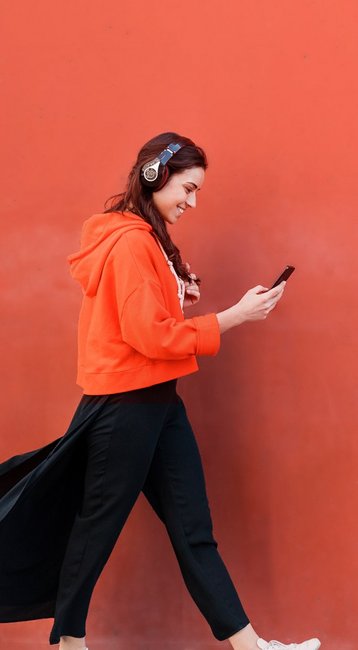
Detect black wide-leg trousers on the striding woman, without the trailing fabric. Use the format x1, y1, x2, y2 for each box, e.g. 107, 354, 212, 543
50, 379, 249, 644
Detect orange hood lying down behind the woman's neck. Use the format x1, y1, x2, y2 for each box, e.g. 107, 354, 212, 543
67, 212, 153, 296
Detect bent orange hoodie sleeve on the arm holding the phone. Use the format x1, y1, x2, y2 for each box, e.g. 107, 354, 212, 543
120, 280, 220, 359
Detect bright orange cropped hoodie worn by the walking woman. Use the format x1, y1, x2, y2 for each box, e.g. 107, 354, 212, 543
67, 212, 220, 395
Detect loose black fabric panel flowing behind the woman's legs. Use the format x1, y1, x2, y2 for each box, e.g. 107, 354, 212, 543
0, 395, 107, 623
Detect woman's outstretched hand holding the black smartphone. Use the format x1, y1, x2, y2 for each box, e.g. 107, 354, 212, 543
231, 280, 286, 324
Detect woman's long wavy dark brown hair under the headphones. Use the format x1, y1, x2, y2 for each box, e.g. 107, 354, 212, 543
104, 132, 208, 284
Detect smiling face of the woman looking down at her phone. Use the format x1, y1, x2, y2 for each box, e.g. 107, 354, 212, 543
153, 167, 205, 224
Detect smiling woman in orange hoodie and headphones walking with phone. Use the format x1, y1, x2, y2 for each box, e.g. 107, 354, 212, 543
0, 133, 320, 650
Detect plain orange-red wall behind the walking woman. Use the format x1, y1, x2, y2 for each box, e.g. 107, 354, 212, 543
0, 0, 358, 650
